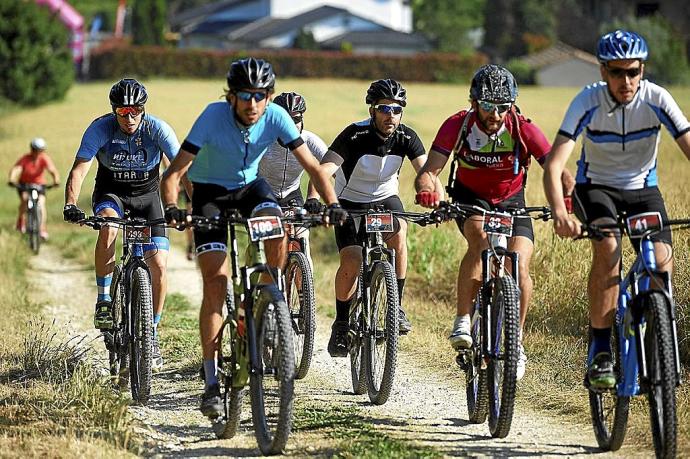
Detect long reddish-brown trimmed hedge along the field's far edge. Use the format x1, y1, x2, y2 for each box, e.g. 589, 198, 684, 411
89, 45, 487, 82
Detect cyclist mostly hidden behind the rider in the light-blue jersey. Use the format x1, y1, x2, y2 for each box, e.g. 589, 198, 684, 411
259, 92, 328, 265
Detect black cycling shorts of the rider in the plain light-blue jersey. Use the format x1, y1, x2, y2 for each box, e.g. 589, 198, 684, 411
192, 177, 282, 254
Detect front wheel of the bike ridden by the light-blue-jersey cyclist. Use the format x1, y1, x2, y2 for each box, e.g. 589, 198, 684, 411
249, 285, 295, 454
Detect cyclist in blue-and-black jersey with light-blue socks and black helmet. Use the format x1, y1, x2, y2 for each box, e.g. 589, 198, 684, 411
63, 78, 180, 369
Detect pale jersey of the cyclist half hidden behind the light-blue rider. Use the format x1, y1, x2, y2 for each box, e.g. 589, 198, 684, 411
259, 130, 328, 199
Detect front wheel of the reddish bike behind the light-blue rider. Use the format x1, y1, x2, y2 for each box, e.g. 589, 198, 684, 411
285, 252, 316, 379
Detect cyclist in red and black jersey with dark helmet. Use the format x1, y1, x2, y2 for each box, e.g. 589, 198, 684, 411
415, 64, 574, 379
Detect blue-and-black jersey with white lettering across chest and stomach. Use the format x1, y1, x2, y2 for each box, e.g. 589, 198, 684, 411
77, 113, 180, 196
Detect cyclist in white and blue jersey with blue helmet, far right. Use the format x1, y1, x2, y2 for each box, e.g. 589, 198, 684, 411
544, 30, 690, 389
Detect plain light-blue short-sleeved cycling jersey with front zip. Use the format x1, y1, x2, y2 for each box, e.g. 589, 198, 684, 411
182, 101, 303, 190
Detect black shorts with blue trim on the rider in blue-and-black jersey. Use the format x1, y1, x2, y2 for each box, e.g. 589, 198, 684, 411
91, 189, 168, 241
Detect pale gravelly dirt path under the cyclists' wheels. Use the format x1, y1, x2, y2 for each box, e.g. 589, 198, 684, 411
31, 246, 632, 457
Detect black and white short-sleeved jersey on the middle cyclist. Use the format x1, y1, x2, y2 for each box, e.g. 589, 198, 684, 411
328, 119, 425, 202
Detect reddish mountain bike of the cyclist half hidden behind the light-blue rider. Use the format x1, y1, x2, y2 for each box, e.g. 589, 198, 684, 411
283, 206, 323, 379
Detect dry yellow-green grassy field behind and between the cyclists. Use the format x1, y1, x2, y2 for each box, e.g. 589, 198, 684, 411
0, 78, 690, 452
